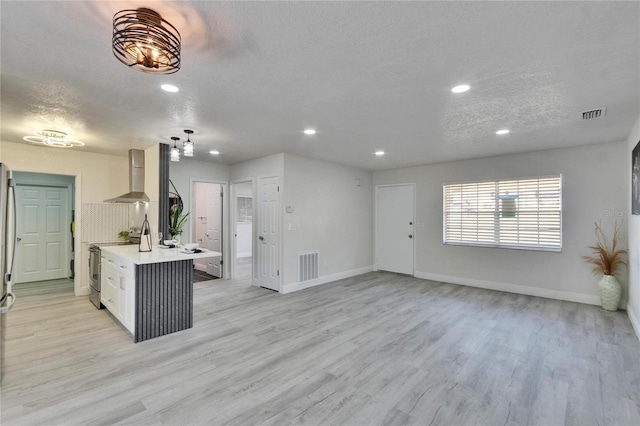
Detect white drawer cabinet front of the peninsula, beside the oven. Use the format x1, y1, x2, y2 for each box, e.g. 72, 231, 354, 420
100, 253, 136, 334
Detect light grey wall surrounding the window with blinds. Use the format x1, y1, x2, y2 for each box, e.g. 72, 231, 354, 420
373, 142, 627, 304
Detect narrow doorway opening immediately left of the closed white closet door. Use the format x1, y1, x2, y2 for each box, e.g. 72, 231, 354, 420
232, 181, 253, 279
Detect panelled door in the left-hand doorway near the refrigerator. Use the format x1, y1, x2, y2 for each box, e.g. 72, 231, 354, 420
15, 185, 70, 284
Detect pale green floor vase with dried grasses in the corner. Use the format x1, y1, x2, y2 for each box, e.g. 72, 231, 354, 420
582, 222, 627, 311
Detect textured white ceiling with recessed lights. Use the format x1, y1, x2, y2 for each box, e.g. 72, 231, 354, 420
0, 1, 640, 170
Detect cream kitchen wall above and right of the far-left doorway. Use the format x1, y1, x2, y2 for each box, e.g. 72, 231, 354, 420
0, 142, 129, 296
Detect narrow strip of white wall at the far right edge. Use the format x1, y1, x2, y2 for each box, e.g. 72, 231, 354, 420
626, 117, 640, 338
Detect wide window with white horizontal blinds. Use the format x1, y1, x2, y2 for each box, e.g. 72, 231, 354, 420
443, 176, 562, 251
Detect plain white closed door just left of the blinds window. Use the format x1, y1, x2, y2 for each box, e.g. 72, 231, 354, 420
376, 185, 415, 275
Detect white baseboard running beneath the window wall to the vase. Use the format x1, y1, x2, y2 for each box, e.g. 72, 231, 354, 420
415, 271, 600, 305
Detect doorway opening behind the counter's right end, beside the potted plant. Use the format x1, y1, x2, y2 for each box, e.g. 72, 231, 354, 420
191, 181, 224, 282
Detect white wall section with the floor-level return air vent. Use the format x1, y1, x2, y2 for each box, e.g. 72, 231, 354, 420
281, 154, 373, 293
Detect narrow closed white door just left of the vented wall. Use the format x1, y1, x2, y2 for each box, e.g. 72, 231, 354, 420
257, 176, 280, 291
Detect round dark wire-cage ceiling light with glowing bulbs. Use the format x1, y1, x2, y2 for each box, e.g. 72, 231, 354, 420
112, 8, 181, 74
